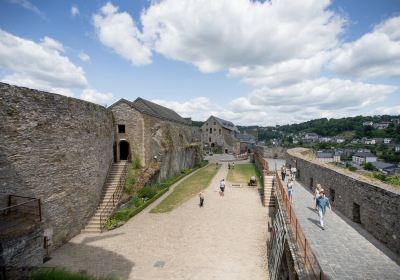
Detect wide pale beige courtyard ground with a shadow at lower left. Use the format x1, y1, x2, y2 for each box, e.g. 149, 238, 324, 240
44, 164, 268, 280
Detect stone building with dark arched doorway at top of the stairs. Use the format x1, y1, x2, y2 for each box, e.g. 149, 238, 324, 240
109, 98, 200, 179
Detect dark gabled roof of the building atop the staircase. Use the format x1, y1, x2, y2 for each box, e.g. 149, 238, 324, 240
109, 97, 190, 125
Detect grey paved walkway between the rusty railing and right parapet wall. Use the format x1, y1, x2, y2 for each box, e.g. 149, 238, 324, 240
293, 178, 400, 279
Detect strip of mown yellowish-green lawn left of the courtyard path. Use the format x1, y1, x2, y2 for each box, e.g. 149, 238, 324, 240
150, 165, 221, 213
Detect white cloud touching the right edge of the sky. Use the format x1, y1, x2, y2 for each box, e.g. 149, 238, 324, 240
329, 17, 400, 79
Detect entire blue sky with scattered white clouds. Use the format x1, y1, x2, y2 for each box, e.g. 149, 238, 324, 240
0, 0, 400, 125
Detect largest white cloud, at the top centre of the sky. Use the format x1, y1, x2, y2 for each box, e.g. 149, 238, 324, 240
141, 0, 344, 72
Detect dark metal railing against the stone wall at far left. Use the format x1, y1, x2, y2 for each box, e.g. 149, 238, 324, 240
0, 195, 42, 222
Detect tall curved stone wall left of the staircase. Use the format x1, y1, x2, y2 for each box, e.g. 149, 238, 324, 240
0, 83, 114, 248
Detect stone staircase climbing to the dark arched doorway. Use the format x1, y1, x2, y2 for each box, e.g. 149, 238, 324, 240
81, 161, 127, 233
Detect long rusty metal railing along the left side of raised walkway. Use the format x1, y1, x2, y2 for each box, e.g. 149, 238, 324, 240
275, 173, 324, 279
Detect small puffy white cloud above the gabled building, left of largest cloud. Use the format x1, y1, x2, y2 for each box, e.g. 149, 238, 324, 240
93, 3, 151, 65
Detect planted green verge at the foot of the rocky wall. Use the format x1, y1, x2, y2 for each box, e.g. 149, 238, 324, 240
104, 161, 208, 230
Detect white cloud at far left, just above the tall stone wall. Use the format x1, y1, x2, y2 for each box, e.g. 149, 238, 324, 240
0, 29, 88, 90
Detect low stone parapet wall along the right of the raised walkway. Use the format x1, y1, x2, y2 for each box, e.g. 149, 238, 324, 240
287, 148, 400, 254
